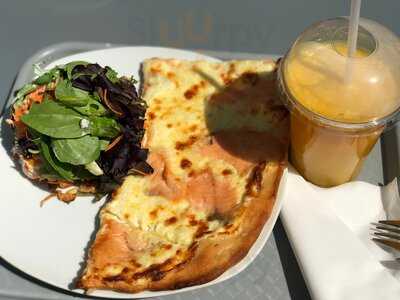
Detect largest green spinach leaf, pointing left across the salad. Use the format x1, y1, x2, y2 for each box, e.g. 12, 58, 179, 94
21, 100, 88, 138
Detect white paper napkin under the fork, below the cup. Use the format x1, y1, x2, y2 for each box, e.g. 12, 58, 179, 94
282, 168, 400, 300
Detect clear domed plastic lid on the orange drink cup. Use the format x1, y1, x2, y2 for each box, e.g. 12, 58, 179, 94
281, 18, 400, 127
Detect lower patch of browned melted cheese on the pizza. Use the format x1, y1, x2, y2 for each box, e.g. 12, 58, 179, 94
107, 176, 219, 268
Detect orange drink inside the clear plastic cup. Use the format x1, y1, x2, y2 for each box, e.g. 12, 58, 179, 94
283, 42, 399, 187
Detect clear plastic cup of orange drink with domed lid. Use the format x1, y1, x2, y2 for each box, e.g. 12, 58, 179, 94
278, 18, 400, 187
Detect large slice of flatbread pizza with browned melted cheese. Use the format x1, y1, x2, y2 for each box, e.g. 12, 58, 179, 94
77, 58, 289, 293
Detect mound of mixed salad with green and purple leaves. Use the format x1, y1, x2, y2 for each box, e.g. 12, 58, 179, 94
9, 61, 152, 198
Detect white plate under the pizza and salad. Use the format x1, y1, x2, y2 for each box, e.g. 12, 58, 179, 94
0, 47, 286, 298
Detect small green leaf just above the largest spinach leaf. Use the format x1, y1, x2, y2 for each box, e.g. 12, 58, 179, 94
55, 80, 91, 106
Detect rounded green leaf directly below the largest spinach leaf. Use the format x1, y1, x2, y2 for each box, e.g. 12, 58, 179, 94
51, 135, 100, 166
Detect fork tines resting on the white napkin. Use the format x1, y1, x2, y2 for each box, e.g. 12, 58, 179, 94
372, 220, 400, 251
